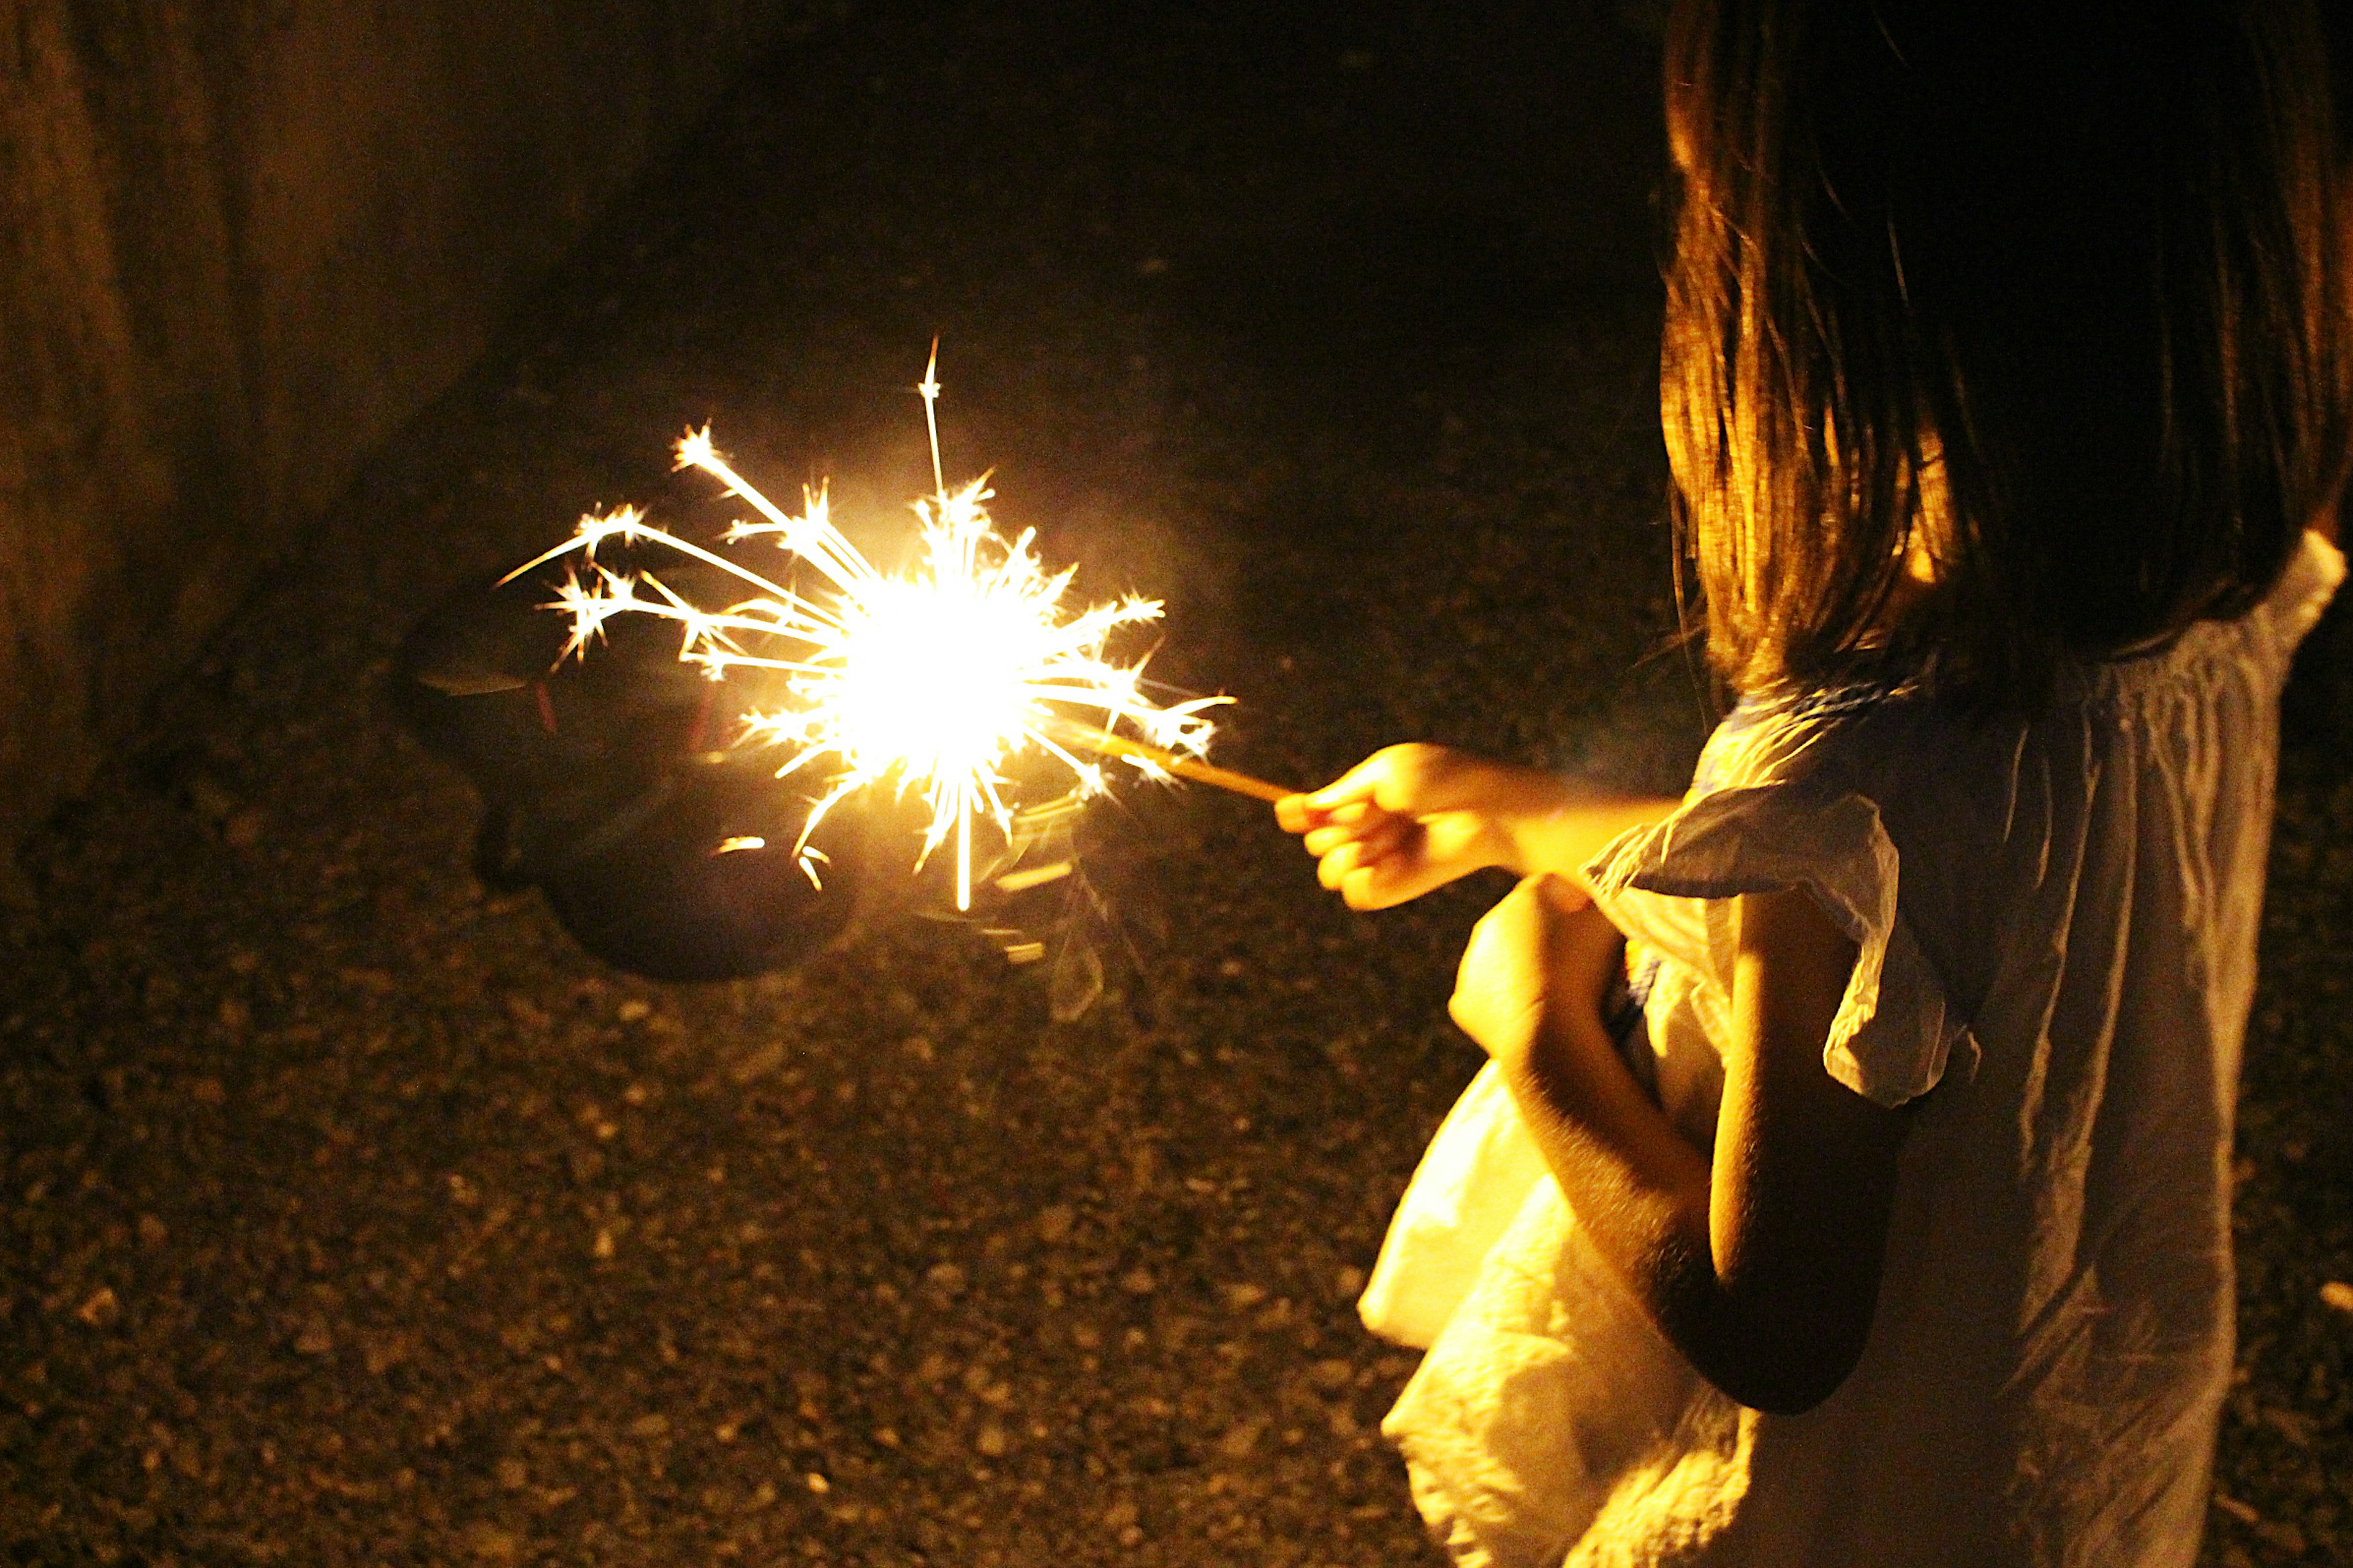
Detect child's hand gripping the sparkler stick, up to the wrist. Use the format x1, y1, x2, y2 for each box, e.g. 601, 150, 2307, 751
1275, 744, 1520, 909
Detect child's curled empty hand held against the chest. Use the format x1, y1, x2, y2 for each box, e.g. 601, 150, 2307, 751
1447, 876, 1626, 1071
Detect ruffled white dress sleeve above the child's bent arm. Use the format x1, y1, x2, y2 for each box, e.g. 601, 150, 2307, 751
1586, 782, 1967, 1107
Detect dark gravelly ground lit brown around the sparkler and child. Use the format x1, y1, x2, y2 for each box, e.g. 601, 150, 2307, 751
0, 5, 2353, 1568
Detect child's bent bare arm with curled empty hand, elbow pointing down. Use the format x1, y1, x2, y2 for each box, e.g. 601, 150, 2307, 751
1452, 878, 1908, 1412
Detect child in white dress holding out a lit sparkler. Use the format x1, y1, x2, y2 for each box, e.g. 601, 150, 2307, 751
1278, 0, 2353, 1568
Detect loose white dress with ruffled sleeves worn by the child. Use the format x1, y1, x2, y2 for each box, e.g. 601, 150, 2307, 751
1362, 534, 2344, 1568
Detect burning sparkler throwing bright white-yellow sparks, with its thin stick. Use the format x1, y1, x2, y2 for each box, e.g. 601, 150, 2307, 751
508, 341, 1289, 909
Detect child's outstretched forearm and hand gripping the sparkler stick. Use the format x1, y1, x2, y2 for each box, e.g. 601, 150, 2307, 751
1275, 744, 1680, 909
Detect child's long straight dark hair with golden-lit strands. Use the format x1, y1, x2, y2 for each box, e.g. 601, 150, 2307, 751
1661, 0, 2353, 711
